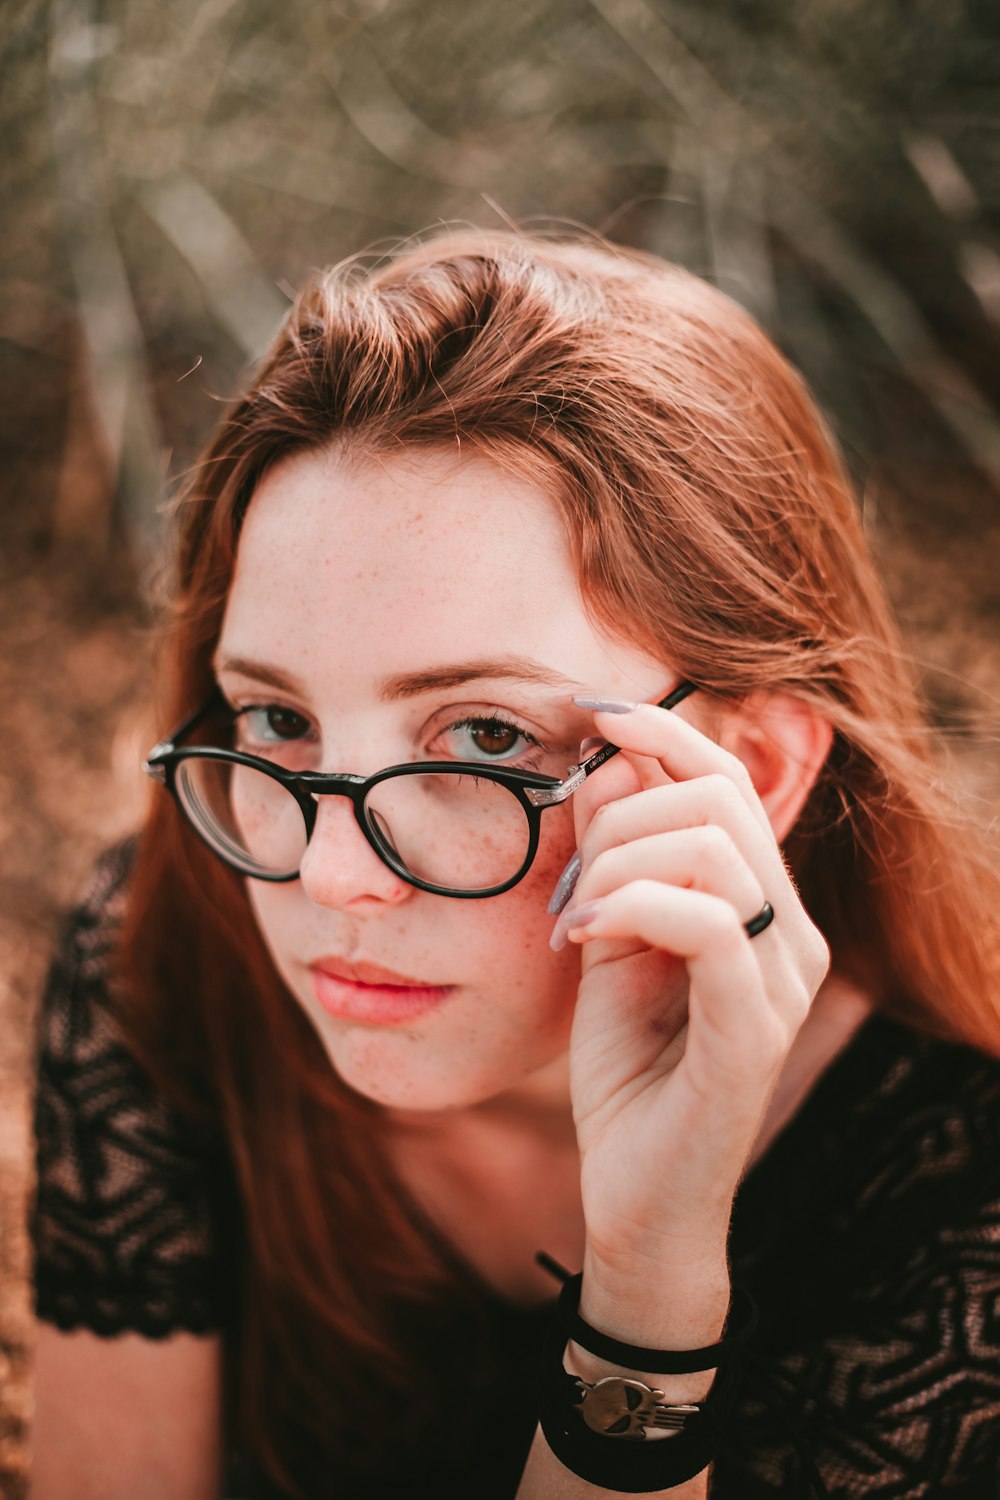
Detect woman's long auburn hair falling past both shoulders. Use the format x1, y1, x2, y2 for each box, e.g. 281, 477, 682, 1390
121, 231, 1000, 1494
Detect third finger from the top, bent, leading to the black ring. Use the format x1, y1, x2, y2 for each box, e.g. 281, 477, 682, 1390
576, 824, 766, 923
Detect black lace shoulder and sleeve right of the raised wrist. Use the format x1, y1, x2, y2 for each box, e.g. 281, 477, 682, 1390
728, 1016, 1000, 1500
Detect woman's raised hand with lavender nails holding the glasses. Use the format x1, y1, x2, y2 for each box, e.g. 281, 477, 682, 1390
553, 690, 829, 1314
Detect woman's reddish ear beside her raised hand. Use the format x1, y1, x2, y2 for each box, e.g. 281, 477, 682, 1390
718, 693, 834, 843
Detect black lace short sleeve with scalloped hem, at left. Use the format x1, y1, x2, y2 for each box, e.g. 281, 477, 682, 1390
31, 845, 232, 1337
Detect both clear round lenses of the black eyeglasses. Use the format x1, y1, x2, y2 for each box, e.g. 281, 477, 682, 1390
175, 756, 531, 891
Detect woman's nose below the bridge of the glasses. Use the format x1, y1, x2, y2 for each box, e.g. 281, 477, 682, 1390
298, 797, 415, 909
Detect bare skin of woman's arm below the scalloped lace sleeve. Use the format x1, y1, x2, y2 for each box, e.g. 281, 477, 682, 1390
31, 1323, 222, 1500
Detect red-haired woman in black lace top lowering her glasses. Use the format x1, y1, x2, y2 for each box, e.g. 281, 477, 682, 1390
34, 233, 1000, 1500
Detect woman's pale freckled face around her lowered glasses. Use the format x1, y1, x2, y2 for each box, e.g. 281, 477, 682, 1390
216, 450, 673, 1110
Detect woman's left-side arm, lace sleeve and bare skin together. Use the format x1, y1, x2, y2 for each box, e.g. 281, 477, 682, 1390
31, 846, 235, 1500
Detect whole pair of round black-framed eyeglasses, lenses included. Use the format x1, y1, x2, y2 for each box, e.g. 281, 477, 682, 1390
142, 683, 694, 900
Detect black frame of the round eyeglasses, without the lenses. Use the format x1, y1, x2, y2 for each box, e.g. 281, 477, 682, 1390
142, 681, 696, 900
